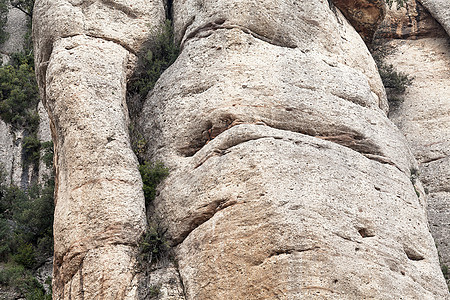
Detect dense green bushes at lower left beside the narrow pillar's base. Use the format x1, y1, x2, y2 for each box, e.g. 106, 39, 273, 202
0, 168, 54, 300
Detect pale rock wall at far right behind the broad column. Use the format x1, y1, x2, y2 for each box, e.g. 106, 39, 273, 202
376, 1, 450, 274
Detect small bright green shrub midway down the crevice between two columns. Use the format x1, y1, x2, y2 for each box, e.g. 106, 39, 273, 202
139, 162, 169, 206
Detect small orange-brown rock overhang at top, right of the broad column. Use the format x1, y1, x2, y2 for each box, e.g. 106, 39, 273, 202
332, 0, 386, 42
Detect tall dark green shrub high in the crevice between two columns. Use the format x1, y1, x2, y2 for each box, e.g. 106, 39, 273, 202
128, 20, 179, 97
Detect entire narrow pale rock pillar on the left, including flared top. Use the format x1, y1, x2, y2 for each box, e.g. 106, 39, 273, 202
33, 0, 165, 299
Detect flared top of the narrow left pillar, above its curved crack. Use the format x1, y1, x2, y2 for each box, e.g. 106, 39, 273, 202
33, 0, 165, 99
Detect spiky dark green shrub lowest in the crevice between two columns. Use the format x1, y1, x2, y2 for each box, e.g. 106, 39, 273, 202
139, 223, 169, 264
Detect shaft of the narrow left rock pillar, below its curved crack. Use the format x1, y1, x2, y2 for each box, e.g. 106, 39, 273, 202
46, 36, 145, 299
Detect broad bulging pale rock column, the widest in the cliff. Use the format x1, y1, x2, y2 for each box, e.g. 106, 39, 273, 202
140, 0, 448, 299
